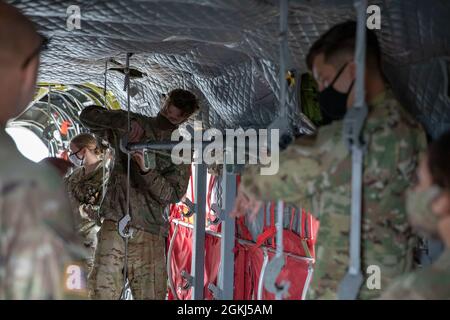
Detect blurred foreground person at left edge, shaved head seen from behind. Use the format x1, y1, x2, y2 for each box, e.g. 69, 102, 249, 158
0, 1, 86, 300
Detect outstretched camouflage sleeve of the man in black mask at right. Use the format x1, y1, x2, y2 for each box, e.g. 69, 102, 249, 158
240, 138, 321, 205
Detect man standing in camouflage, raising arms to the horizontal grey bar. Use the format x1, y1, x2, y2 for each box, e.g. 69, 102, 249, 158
80, 89, 198, 299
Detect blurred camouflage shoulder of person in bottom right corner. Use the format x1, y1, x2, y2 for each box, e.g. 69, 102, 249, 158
381, 248, 450, 300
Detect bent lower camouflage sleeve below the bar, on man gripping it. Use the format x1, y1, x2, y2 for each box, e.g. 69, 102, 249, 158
142, 164, 190, 205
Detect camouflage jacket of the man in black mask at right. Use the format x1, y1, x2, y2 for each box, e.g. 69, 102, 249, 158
241, 91, 426, 299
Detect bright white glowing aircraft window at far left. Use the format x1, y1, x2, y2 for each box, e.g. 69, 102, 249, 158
6, 127, 48, 162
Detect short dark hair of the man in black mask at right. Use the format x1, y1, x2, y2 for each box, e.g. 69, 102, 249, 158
306, 21, 381, 70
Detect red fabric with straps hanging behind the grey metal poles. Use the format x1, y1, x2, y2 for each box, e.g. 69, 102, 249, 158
168, 170, 319, 300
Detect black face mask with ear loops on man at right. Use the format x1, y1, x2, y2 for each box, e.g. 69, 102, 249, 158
319, 62, 355, 122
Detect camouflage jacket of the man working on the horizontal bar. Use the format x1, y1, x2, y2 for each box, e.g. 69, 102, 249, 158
80, 106, 190, 236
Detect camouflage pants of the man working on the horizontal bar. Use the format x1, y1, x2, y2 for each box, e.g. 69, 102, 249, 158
88, 220, 167, 300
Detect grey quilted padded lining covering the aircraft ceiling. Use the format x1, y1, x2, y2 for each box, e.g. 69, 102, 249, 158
8, 0, 450, 136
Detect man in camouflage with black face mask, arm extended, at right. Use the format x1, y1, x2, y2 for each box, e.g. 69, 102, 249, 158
237, 22, 426, 299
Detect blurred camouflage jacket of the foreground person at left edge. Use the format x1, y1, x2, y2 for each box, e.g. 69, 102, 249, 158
0, 182, 86, 299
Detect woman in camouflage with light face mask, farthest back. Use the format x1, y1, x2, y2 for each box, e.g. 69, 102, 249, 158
64, 133, 111, 270
